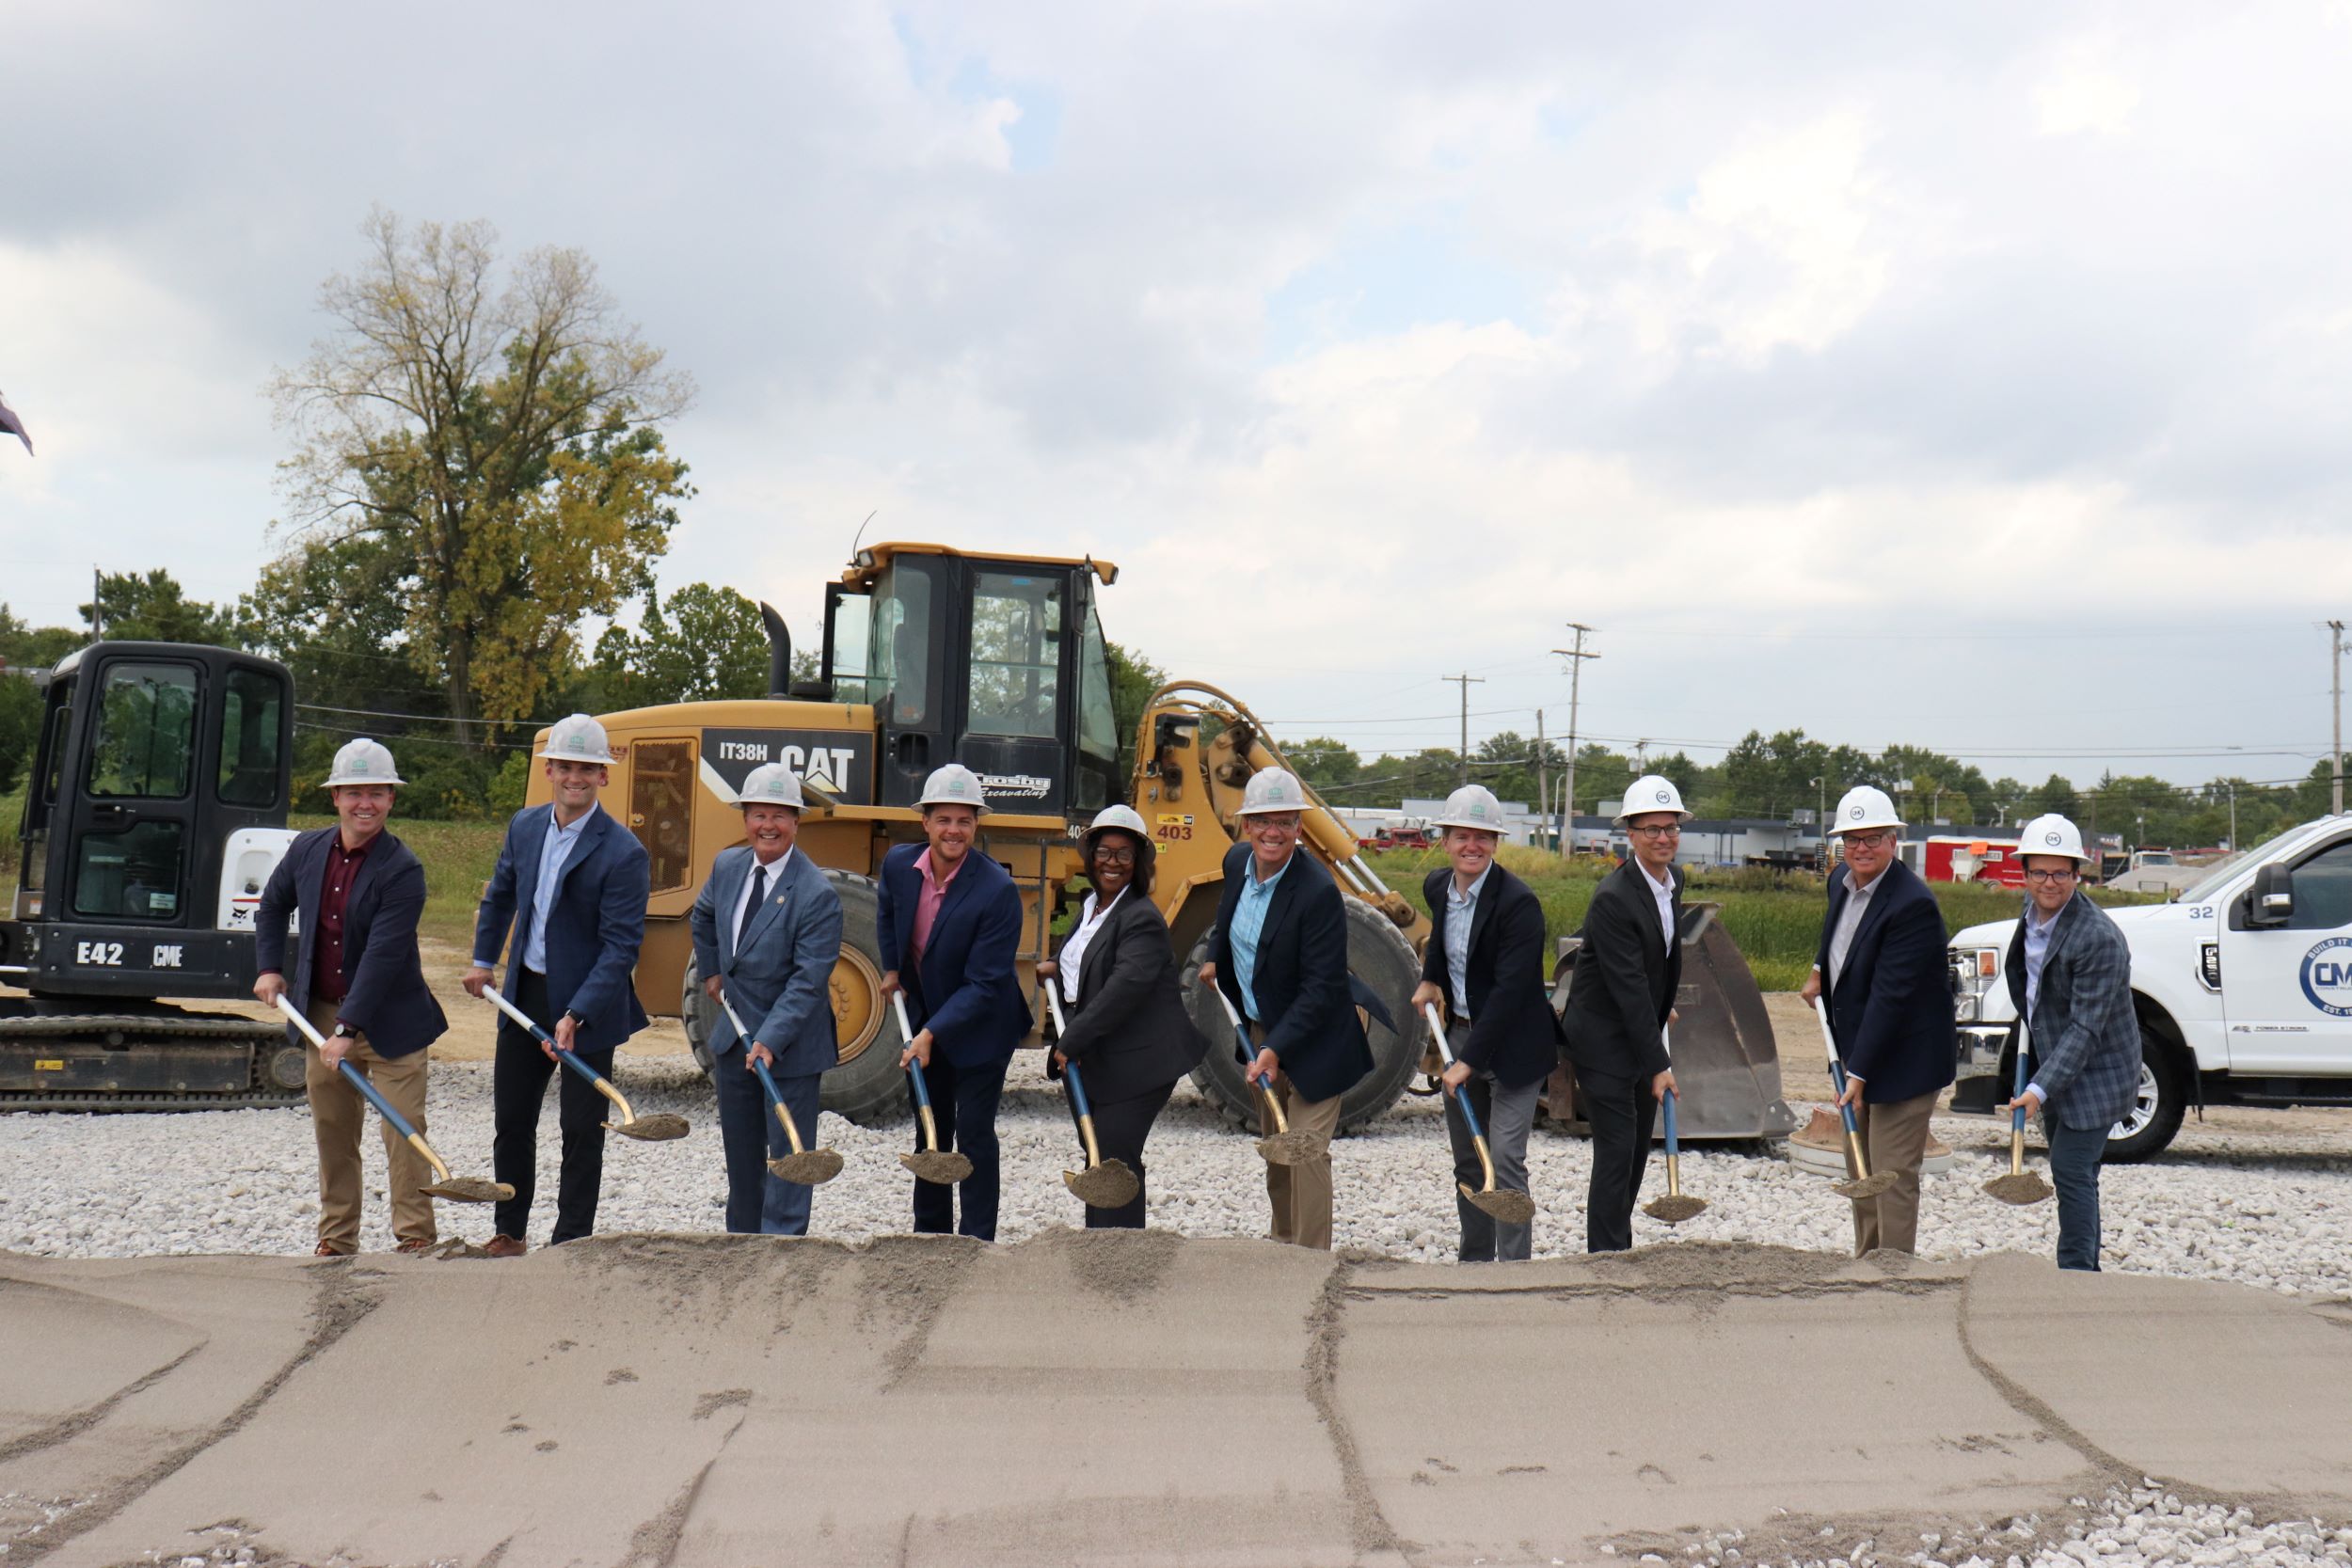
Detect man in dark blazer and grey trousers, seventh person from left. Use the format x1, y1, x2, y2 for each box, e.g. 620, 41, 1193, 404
1414, 785, 1560, 1262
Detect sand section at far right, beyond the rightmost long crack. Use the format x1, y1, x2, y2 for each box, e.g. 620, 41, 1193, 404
1966, 1253, 2352, 1512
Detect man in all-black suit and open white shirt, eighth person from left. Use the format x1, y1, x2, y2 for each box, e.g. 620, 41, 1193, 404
1566, 773, 1692, 1253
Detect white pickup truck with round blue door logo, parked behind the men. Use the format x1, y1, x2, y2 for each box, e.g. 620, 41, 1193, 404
1952, 814, 2352, 1162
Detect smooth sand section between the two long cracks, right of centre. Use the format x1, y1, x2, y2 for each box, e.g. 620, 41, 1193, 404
1339, 1243, 2087, 1561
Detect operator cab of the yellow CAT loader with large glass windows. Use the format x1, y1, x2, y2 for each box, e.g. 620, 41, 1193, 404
823, 546, 1120, 818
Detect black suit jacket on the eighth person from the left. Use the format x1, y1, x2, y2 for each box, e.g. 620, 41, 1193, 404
1562, 861, 1682, 1079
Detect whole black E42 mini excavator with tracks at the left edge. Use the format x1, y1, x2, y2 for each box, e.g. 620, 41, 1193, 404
0, 641, 301, 1110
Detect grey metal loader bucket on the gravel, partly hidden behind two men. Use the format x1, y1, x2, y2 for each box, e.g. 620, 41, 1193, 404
1543, 903, 1797, 1143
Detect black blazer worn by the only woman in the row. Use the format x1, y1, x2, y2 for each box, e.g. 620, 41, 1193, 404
1047, 886, 1209, 1105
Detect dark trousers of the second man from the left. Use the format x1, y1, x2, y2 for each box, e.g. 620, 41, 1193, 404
489, 964, 612, 1242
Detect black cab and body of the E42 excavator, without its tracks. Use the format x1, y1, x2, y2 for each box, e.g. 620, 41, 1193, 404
0, 641, 294, 997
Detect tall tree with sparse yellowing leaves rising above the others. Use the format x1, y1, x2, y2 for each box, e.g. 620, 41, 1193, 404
271, 209, 694, 740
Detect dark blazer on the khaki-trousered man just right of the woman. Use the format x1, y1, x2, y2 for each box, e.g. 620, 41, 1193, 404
1209, 844, 1372, 1101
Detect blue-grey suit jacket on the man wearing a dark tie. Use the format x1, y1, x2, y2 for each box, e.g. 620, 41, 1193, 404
687, 844, 842, 1079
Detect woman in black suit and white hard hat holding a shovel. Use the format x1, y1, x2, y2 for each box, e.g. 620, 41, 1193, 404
1038, 806, 1209, 1229
